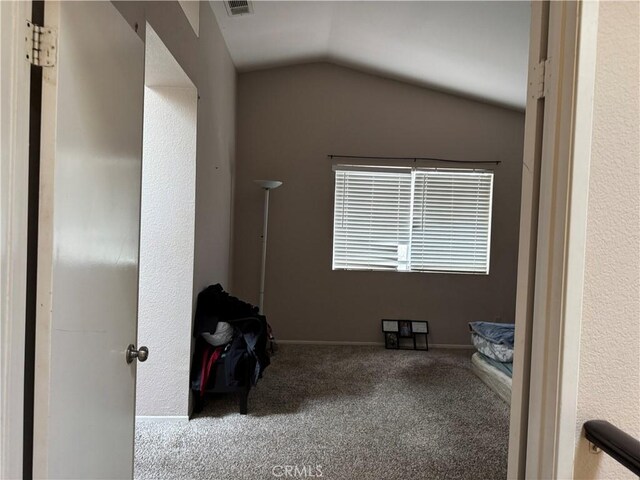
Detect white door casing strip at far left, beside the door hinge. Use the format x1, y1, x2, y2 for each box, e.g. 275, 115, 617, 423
0, 2, 31, 478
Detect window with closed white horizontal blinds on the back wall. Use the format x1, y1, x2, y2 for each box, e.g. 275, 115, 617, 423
333, 165, 493, 274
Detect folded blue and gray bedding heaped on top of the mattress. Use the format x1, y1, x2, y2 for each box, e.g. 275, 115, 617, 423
469, 322, 515, 378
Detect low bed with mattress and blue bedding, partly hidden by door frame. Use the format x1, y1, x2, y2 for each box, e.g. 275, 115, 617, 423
469, 322, 514, 404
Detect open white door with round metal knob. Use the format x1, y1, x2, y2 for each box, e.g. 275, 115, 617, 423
34, 0, 144, 479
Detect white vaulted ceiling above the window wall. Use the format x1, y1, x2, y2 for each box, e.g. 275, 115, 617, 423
211, 1, 530, 109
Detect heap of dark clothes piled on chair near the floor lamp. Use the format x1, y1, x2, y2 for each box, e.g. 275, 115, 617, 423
191, 284, 270, 395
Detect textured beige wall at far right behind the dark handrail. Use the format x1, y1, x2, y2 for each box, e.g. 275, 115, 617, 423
575, 2, 640, 479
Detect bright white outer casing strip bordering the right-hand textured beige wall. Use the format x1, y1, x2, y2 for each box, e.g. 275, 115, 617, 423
554, 2, 599, 478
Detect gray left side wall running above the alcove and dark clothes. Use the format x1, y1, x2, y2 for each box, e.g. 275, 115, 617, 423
114, 1, 236, 306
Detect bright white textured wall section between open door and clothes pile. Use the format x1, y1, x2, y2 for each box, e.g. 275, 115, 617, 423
136, 87, 197, 416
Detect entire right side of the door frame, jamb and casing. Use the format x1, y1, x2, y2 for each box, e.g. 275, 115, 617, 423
507, 1, 599, 479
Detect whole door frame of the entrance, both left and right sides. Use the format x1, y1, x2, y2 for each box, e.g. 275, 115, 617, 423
0, 1, 598, 478
